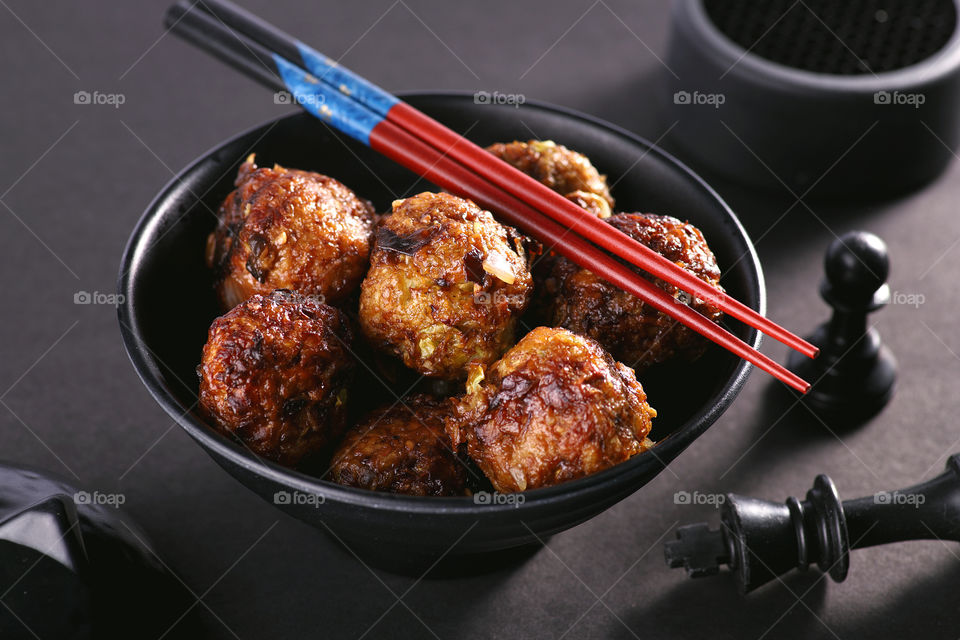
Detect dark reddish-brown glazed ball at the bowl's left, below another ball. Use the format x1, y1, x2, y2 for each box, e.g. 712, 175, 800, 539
198, 291, 354, 466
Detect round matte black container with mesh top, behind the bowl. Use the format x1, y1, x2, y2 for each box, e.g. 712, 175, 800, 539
662, 0, 960, 199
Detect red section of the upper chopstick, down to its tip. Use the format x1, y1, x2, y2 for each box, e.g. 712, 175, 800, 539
387, 107, 819, 358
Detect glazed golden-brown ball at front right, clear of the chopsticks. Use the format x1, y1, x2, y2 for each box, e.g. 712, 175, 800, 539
447, 327, 656, 492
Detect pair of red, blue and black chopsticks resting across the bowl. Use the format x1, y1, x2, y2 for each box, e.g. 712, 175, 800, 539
166, 0, 818, 393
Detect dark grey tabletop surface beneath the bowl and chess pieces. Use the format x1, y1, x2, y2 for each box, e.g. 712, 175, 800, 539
0, 0, 960, 639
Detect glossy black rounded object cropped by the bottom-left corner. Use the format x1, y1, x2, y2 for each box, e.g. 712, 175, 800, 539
0, 463, 192, 639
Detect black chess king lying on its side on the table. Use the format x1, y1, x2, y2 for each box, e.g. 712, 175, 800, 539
664, 454, 960, 593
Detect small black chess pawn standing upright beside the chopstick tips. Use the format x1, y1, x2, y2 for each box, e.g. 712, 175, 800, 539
787, 231, 897, 424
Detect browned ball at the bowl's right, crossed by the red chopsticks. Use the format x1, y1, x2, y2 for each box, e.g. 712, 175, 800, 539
538, 213, 723, 371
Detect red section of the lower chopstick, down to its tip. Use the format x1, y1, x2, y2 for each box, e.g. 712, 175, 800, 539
370, 120, 810, 393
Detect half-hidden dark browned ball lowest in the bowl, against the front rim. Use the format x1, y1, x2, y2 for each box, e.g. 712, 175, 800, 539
330, 395, 467, 496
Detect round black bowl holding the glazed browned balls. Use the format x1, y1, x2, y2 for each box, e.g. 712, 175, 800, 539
119, 94, 765, 568
